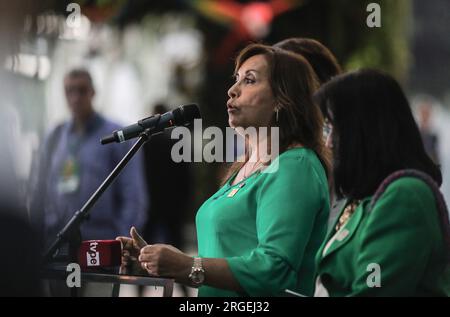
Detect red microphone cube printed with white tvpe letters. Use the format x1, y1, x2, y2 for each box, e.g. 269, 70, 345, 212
78, 240, 122, 271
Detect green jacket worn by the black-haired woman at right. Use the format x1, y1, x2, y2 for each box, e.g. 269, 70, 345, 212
317, 177, 450, 296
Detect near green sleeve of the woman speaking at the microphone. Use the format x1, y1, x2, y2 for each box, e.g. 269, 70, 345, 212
226, 156, 329, 296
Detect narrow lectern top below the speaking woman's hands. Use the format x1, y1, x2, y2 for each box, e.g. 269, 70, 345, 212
41, 269, 174, 297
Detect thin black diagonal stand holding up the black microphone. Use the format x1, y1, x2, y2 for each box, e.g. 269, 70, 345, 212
44, 128, 153, 264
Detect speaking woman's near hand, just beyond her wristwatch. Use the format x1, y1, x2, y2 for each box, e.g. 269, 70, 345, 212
139, 244, 193, 280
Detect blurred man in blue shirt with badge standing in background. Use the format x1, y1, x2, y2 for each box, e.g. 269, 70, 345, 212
30, 69, 147, 245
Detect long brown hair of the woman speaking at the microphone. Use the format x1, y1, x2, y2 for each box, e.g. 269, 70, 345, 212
224, 44, 330, 181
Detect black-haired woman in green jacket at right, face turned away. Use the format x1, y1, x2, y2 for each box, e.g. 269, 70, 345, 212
314, 70, 450, 296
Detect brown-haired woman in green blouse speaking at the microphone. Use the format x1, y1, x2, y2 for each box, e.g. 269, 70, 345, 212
118, 44, 329, 296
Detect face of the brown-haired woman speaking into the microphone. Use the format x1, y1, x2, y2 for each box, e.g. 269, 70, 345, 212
227, 54, 276, 129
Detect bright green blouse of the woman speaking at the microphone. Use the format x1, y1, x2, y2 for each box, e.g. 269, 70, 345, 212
196, 148, 329, 296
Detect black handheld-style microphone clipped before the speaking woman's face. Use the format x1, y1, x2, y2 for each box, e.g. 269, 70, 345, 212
100, 104, 201, 144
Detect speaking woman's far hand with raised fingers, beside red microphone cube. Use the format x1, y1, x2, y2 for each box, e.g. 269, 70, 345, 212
116, 227, 147, 275
